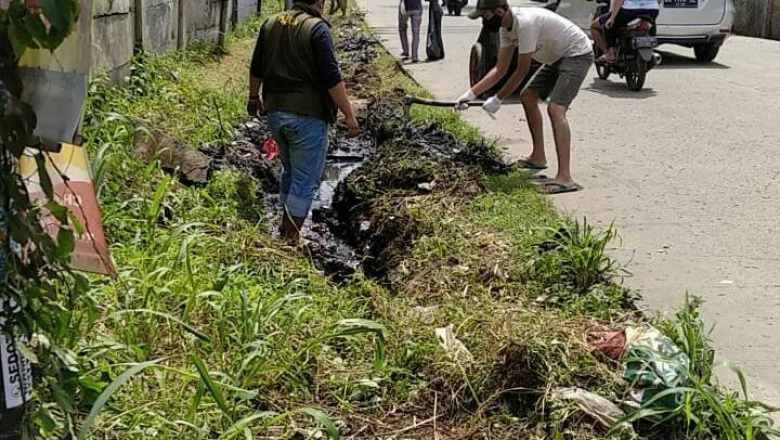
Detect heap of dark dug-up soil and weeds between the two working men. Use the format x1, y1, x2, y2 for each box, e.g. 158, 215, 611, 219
323, 101, 509, 280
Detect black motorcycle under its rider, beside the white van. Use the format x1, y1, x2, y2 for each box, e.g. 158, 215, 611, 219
593, 2, 661, 92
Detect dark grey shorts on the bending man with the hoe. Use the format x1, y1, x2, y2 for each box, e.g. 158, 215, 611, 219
528, 53, 593, 107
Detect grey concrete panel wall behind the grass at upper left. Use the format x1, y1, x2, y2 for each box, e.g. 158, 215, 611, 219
92, 0, 256, 84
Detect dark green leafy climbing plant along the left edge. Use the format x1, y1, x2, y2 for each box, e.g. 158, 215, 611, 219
0, 0, 94, 438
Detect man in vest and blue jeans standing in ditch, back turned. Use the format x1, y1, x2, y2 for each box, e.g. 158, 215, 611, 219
247, 0, 360, 242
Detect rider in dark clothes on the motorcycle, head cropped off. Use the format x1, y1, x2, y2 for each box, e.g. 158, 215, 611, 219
592, 0, 660, 63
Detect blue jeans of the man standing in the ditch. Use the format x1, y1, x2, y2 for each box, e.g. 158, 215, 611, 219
268, 112, 328, 218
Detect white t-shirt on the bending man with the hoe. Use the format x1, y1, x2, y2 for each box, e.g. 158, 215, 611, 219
499, 7, 593, 64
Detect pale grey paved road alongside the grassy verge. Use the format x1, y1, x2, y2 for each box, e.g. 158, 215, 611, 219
361, 0, 780, 406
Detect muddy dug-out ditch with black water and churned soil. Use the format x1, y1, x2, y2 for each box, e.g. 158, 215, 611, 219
204, 19, 509, 282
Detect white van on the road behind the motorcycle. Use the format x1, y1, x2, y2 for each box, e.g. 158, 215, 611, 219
557, 0, 734, 62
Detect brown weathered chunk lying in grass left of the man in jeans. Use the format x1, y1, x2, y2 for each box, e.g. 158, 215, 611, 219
133, 128, 211, 185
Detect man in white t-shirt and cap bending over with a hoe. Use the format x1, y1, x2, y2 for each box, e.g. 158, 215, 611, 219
458, 0, 593, 194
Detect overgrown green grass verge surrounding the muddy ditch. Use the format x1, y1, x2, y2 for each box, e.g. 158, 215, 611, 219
46, 2, 772, 439
